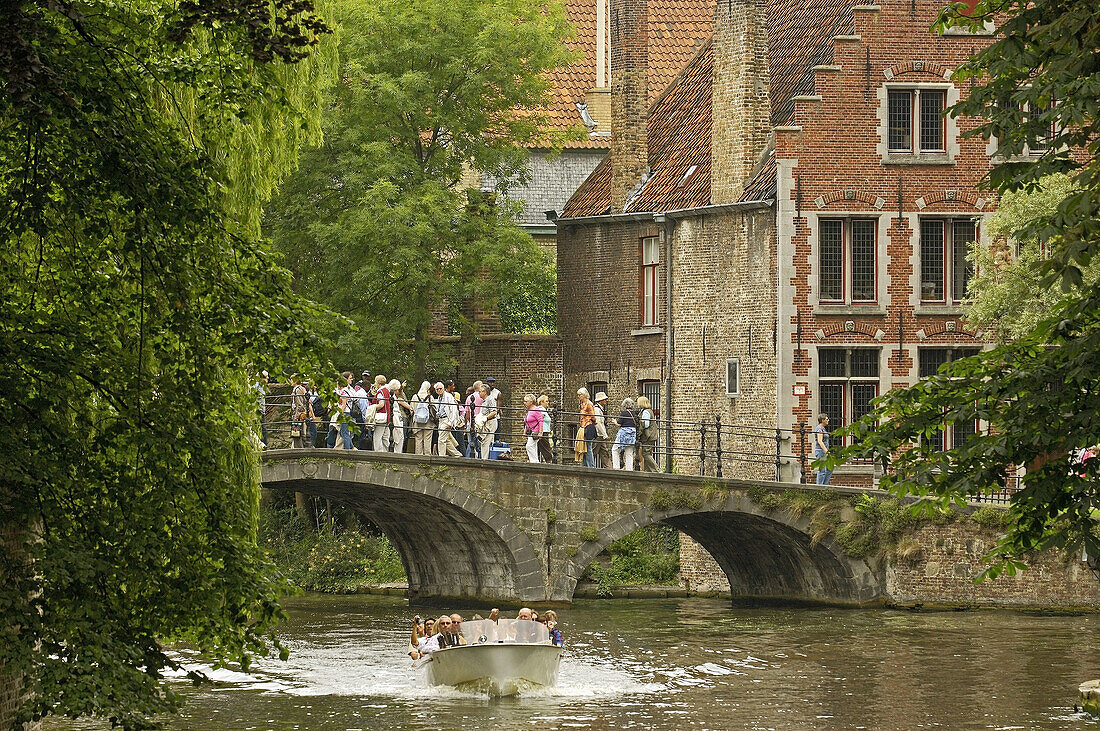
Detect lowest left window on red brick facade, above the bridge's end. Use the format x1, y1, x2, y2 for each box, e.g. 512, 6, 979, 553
817, 347, 880, 448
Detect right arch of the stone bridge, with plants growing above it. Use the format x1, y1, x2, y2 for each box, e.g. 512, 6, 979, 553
553, 495, 881, 605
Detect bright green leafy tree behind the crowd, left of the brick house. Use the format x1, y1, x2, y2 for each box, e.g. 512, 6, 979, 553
265, 0, 570, 373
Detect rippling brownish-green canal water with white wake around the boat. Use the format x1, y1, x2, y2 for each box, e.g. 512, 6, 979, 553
47, 596, 1100, 731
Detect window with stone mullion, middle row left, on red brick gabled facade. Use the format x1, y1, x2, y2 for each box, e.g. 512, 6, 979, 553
818, 219, 878, 302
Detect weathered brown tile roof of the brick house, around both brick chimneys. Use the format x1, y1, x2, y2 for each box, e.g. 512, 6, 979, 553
561, 0, 851, 218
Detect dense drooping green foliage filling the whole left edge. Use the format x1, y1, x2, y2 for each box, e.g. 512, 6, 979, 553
0, 0, 331, 728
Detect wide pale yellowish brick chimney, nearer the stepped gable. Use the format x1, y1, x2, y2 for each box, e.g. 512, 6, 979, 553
711, 0, 771, 204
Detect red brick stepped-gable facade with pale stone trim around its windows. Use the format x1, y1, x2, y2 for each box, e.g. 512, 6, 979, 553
776, 0, 1007, 484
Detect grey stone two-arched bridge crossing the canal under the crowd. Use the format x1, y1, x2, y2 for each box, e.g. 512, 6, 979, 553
262, 450, 883, 605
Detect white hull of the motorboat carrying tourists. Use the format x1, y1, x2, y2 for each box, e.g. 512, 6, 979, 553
425, 643, 561, 696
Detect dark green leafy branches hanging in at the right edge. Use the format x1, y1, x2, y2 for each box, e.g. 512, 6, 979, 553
829, 0, 1100, 576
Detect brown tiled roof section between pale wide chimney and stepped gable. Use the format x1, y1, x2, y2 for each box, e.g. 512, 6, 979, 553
768, 0, 853, 125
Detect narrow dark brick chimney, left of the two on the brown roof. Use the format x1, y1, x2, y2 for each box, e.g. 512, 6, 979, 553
611, 0, 649, 213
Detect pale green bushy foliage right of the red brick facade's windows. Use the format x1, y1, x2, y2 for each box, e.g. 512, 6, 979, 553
966, 174, 1100, 342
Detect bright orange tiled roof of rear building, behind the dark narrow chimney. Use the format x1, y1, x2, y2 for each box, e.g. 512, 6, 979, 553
542, 0, 715, 149
